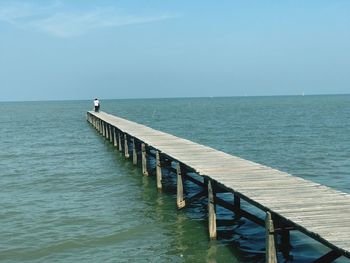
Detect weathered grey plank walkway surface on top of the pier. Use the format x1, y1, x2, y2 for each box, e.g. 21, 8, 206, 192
88, 111, 350, 262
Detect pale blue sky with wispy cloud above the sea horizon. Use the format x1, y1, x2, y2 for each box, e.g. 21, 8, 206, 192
0, 0, 350, 101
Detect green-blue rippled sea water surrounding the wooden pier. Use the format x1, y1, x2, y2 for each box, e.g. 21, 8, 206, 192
0, 95, 350, 262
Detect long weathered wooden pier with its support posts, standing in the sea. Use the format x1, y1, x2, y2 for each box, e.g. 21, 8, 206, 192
87, 111, 350, 262
